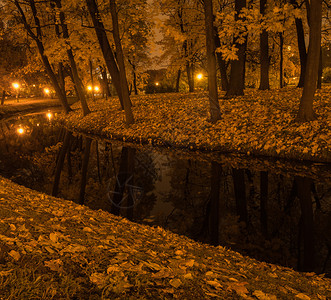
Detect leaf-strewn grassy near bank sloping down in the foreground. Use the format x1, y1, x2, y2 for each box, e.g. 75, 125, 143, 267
0, 178, 331, 300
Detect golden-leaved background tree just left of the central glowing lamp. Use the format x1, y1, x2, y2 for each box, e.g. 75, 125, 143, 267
154, 0, 205, 92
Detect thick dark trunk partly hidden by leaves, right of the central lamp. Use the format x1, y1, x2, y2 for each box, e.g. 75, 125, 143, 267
226, 0, 247, 97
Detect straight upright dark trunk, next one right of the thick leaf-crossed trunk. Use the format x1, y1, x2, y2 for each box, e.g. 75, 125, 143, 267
259, 0, 270, 90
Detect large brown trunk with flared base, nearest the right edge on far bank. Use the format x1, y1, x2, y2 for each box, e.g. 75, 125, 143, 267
296, 0, 322, 122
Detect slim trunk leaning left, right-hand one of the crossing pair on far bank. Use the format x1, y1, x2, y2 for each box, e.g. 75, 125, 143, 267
109, 0, 134, 125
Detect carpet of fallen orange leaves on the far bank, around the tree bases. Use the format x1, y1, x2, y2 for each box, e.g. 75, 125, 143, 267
60, 87, 331, 162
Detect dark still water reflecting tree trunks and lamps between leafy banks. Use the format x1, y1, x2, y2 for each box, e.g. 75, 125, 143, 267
0, 112, 331, 276
